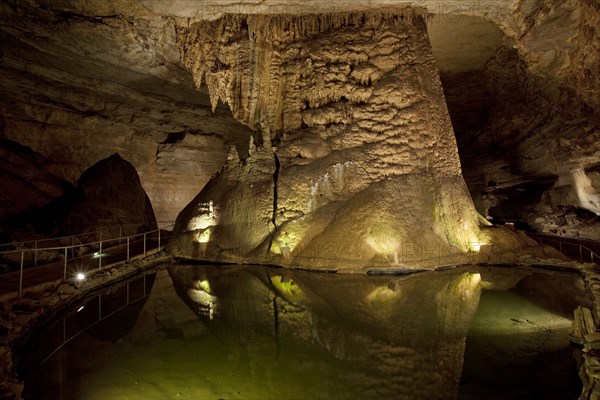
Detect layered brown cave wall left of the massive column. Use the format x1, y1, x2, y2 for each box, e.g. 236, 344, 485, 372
0, 1, 250, 222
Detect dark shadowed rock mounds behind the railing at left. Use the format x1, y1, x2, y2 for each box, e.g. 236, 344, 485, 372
0, 152, 157, 255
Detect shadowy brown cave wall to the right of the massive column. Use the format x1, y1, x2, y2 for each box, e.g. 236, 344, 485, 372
432, 1, 600, 239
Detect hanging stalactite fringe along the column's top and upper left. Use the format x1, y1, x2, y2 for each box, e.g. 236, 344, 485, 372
177, 7, 425, 134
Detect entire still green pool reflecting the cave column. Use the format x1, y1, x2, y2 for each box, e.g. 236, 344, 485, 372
19, 264, 588, 400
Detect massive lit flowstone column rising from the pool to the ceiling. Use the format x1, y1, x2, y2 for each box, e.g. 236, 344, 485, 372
170, 8, 536, 270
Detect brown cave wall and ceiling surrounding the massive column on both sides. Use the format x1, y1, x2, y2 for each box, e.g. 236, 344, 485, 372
0, 0, 600, 238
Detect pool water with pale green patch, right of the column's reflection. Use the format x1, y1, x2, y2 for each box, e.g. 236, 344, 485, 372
459, 291, 582, 400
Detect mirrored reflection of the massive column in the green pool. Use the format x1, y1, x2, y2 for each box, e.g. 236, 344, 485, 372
170, 267, 480, 399
